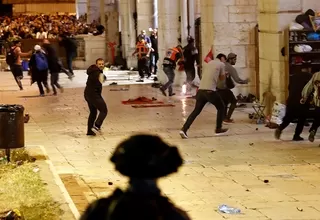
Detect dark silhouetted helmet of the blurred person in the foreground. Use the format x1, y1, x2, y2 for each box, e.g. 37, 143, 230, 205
110, 134, 183, 179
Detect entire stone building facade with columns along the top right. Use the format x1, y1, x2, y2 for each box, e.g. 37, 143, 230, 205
75, 0, 320, 102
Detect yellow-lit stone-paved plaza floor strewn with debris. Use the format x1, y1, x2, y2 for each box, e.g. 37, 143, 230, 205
0, 72, 320, 220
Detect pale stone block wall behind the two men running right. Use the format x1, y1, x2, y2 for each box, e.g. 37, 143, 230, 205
201, 0, 258, 94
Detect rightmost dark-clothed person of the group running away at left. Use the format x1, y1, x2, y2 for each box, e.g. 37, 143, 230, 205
59, 35, 77, 75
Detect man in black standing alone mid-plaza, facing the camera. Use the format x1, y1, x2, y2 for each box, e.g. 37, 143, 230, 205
84, 58, 108, 136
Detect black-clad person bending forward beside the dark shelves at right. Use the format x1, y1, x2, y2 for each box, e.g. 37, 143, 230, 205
274, 69, 312, 141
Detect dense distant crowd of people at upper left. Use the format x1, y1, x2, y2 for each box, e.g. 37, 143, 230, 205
0, 14, 99, 41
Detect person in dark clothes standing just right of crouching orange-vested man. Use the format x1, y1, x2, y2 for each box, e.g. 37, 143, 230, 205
183, 36, 200, 92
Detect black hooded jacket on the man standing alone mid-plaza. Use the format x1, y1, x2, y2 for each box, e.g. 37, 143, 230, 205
84, 65, 106, 96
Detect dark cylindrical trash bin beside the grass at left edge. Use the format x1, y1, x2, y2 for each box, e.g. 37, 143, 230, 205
0, 105, 24, 150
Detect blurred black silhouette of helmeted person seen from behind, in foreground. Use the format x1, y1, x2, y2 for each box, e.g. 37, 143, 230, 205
80, 134, 190, 220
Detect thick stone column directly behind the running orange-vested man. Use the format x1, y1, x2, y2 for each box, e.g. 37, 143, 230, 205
158, 0, 180, 82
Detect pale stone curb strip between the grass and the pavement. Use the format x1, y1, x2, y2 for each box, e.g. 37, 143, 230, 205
26, 145, 80, 220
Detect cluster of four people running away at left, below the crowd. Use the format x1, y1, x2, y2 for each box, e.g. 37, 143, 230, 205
6, 35, 77, 93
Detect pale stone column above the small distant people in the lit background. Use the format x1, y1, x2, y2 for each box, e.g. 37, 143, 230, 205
136, 0, 154, 31
